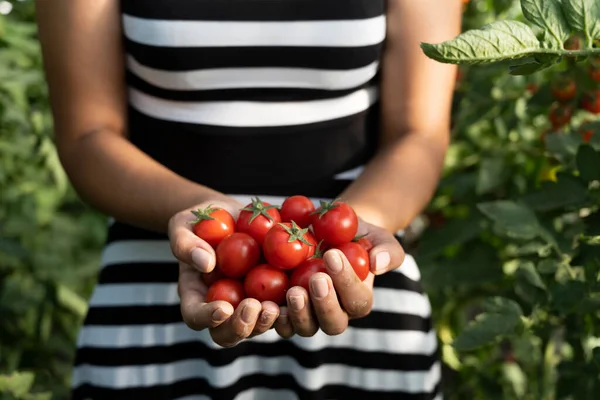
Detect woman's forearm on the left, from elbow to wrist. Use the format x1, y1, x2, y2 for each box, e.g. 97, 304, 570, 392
59, 130, 231, 232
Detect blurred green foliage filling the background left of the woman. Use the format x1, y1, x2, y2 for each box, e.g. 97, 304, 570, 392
0, 1, 106, 400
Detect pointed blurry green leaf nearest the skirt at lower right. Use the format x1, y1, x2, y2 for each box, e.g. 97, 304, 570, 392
453, 297, 522, 351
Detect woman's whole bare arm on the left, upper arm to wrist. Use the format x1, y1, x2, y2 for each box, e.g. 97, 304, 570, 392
36, 0, 230, 232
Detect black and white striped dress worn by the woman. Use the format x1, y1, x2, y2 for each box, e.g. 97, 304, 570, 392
72, 0, 441, 400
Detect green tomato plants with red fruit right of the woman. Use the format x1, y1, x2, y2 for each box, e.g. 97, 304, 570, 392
415, 0, 600, 400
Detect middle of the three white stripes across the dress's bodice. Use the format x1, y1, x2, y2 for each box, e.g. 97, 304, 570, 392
127, 56, 379, 90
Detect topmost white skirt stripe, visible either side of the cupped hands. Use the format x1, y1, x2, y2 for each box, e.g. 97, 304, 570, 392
101, 241, 421, 281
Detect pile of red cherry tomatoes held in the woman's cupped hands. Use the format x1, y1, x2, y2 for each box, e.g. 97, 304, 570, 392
192, 195, 372, 308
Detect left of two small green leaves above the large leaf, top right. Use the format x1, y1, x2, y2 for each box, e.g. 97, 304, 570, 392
521, 0, 571, 49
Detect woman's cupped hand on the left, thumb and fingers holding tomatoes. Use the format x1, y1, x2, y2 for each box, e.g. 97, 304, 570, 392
169, 199, 280, 347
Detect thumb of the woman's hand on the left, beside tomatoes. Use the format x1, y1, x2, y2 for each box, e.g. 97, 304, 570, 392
169, 211, 216, 273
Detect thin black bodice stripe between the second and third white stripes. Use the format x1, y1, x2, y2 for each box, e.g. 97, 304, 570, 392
127, 71, 377, 102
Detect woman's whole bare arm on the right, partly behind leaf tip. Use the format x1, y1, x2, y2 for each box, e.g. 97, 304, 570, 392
342, 0, 462, 231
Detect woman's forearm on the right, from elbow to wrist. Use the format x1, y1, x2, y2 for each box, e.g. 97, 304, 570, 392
341, 133, 448, 232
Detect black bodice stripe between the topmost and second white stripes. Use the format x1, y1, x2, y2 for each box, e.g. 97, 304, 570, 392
125, 44, 383, 71
